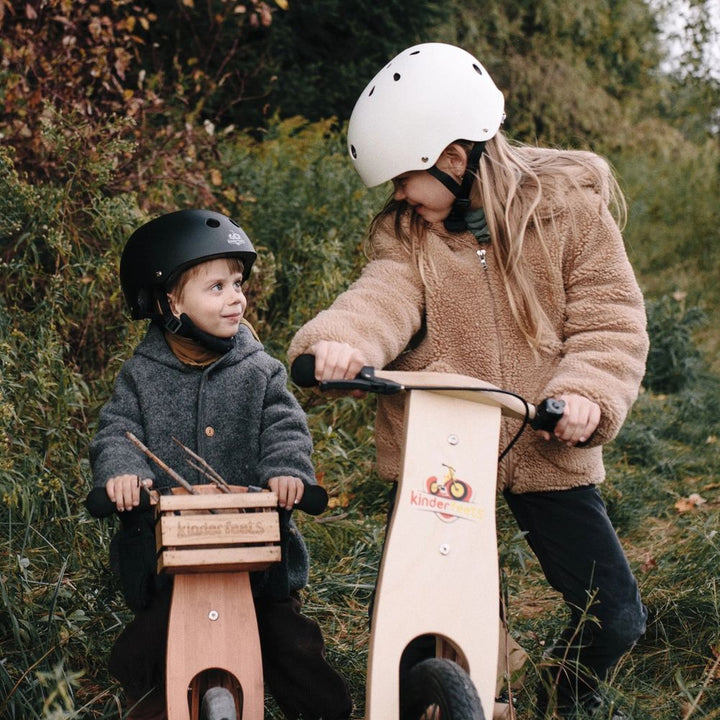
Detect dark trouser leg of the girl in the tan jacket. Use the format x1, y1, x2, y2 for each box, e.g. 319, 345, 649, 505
505, 486, 647, 705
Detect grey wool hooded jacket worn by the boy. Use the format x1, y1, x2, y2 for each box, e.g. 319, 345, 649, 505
90, 324, 316, 591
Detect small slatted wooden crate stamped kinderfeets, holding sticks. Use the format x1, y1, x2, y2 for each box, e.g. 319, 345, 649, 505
155, 485, 281, 574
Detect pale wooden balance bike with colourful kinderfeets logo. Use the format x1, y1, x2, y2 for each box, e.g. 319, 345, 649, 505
292, 355, 564, 720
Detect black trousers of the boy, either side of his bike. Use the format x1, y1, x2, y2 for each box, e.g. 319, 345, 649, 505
110, 588, 352, 720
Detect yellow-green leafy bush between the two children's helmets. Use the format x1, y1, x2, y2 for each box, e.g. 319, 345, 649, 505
221, 118, 386, 355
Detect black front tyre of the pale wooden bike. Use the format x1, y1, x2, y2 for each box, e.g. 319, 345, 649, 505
400, 658, 485, 720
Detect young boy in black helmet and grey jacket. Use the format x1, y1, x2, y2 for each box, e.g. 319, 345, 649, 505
90, 210, 352, 720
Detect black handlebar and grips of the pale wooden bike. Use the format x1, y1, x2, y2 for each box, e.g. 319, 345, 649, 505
290, 354, 565, 432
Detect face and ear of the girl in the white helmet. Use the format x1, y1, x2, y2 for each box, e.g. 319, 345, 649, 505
393, 144, 467, 223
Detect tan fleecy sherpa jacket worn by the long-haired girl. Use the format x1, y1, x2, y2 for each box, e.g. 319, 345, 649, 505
289, 162, 648, 493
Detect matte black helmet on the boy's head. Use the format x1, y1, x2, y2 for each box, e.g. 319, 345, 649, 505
120, 210, 257, 320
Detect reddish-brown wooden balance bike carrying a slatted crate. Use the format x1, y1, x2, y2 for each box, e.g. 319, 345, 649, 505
86, 448, 327, 720
